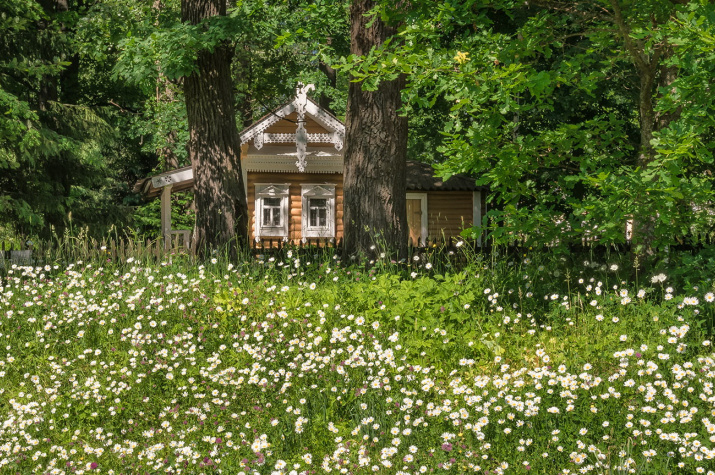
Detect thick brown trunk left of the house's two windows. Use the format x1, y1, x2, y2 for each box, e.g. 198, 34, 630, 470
181, 0, 248, 257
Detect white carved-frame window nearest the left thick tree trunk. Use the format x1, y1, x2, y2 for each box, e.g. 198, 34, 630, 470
254, 184, 289, 240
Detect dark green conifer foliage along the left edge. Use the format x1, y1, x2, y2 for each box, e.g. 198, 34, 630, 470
0, 1, 148, 236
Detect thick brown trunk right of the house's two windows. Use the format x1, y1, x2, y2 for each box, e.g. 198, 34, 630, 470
343, 0, 407, 257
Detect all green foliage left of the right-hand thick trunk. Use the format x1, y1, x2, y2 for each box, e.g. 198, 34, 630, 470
0, 0, 354, 237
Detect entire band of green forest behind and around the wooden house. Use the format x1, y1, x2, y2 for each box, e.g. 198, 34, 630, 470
0, 0, 715, 253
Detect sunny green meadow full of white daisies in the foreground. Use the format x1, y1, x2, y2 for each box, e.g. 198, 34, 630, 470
0, 246, 715, 475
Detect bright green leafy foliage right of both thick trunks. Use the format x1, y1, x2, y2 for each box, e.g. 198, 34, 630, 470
343, 1, 715, 248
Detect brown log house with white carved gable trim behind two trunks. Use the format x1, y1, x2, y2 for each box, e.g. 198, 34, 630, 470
135, 85, 485, 249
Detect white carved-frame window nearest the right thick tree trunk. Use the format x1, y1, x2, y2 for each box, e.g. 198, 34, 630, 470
302, 185, 335, 238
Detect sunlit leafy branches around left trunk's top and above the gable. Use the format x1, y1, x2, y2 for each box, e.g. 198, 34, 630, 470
110, 1, 347, 125
